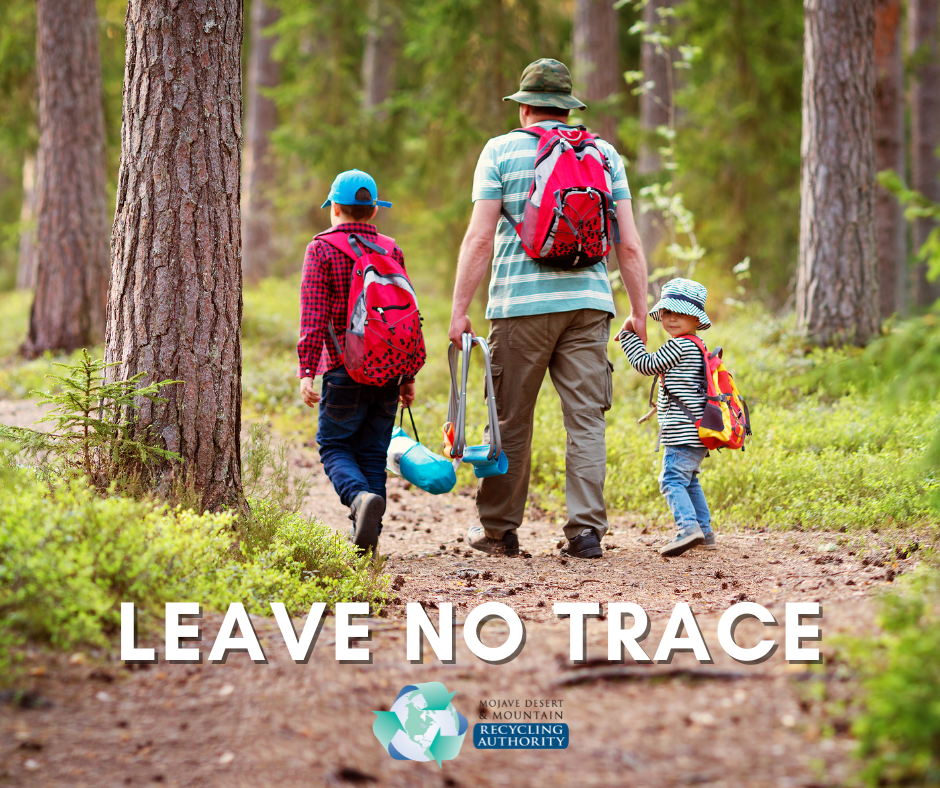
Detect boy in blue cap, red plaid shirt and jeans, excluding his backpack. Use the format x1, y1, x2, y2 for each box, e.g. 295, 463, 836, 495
297, 170, 415, 552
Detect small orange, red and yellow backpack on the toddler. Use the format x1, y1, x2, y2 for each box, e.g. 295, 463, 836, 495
650, 334, 751, 451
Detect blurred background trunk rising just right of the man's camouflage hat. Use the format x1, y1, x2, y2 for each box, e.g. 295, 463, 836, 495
574, 0, 622, 145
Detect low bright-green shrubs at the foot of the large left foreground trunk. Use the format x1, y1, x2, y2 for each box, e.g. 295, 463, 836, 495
0, 468, 388, 674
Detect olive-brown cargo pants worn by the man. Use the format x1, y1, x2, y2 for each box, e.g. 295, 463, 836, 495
476, 309, 613, 539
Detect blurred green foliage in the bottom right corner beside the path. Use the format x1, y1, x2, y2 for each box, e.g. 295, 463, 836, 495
847, 562, 940, 786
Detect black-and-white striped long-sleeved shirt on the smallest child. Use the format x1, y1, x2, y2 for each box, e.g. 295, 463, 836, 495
620, 332, 705, 446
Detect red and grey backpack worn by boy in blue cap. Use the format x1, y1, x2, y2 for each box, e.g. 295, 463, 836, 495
316, 230, 427, 386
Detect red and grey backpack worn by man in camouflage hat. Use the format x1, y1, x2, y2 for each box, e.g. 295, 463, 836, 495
503, 126, 620, 270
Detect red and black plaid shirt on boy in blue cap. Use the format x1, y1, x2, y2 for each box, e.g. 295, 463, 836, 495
297, 222, 405, 378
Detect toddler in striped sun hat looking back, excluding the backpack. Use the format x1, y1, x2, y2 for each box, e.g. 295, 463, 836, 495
619, 279, 717, 556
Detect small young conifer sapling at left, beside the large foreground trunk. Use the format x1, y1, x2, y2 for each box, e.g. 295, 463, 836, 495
0, 350, 179, 489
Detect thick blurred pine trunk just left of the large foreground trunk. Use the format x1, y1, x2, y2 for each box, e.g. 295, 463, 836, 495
23, 0, 108, 356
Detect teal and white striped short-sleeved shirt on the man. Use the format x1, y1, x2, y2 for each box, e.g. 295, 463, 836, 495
473, 120, 630, 320
